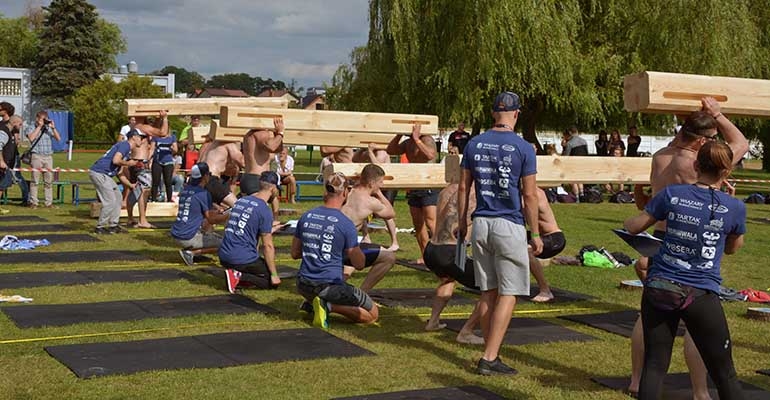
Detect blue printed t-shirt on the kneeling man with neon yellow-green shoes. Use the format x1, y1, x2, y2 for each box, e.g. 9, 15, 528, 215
294, 206, 358, 283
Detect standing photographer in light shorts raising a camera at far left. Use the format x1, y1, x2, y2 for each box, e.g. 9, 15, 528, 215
27, 111, 61, 208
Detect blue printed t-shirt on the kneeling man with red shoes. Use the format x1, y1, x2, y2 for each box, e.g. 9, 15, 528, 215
219, 196, 273, 265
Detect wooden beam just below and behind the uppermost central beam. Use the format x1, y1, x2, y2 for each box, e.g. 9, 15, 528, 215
210, 120, 394, 147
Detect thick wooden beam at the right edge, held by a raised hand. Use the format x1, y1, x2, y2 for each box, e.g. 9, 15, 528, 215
623, 71, 770, 117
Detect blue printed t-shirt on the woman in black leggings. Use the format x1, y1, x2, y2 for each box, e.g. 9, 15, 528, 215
645, 185, 746, 293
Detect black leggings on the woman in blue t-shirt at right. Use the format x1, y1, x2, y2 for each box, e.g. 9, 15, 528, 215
639, 292, 743, 400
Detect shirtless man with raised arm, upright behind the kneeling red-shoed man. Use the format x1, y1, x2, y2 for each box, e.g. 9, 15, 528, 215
241, 118, 284, 212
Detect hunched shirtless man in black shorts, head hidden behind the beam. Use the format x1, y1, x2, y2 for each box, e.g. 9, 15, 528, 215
198, 140, 243, 208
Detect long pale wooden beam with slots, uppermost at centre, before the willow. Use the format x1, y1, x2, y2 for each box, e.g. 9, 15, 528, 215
219, 106, 438, 135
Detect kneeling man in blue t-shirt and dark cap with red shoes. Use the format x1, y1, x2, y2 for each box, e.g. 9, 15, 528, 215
219, 171, 281, 293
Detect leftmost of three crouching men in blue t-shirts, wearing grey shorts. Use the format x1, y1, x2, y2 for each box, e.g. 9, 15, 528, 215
171, 163, 228, 266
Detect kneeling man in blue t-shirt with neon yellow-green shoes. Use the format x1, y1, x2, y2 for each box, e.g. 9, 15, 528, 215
291, 172, 379, 329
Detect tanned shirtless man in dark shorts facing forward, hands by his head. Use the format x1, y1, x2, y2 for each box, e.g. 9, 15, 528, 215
387, 124, 438, 264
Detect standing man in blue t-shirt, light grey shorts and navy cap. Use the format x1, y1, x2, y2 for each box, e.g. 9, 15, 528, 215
458, 92, 543, 375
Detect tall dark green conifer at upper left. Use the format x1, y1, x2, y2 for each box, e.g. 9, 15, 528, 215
32, 0, 125, 107
